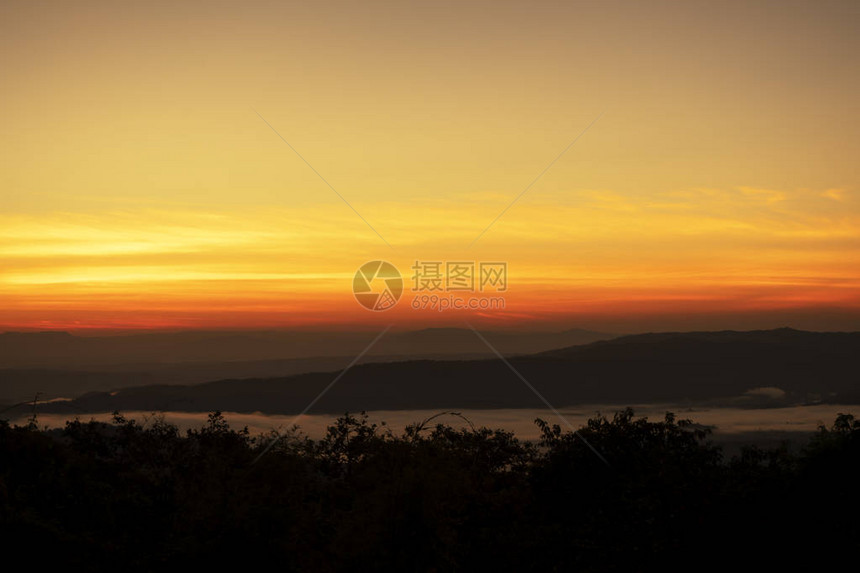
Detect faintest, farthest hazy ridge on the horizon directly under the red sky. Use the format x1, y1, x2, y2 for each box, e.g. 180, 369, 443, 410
0, 328, 615, 369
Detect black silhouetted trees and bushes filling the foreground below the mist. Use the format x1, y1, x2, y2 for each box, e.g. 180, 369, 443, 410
0, 410, 860, 571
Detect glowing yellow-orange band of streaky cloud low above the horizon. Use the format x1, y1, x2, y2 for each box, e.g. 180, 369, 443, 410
0, 187, 860, 325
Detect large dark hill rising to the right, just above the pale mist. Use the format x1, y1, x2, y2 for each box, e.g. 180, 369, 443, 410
30, 329, 860, 414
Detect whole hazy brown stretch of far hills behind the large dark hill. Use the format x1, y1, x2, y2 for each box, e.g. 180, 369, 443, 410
0, 328, 613, 402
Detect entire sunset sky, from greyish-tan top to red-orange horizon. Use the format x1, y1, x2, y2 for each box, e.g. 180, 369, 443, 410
0, 0, 860, 332
